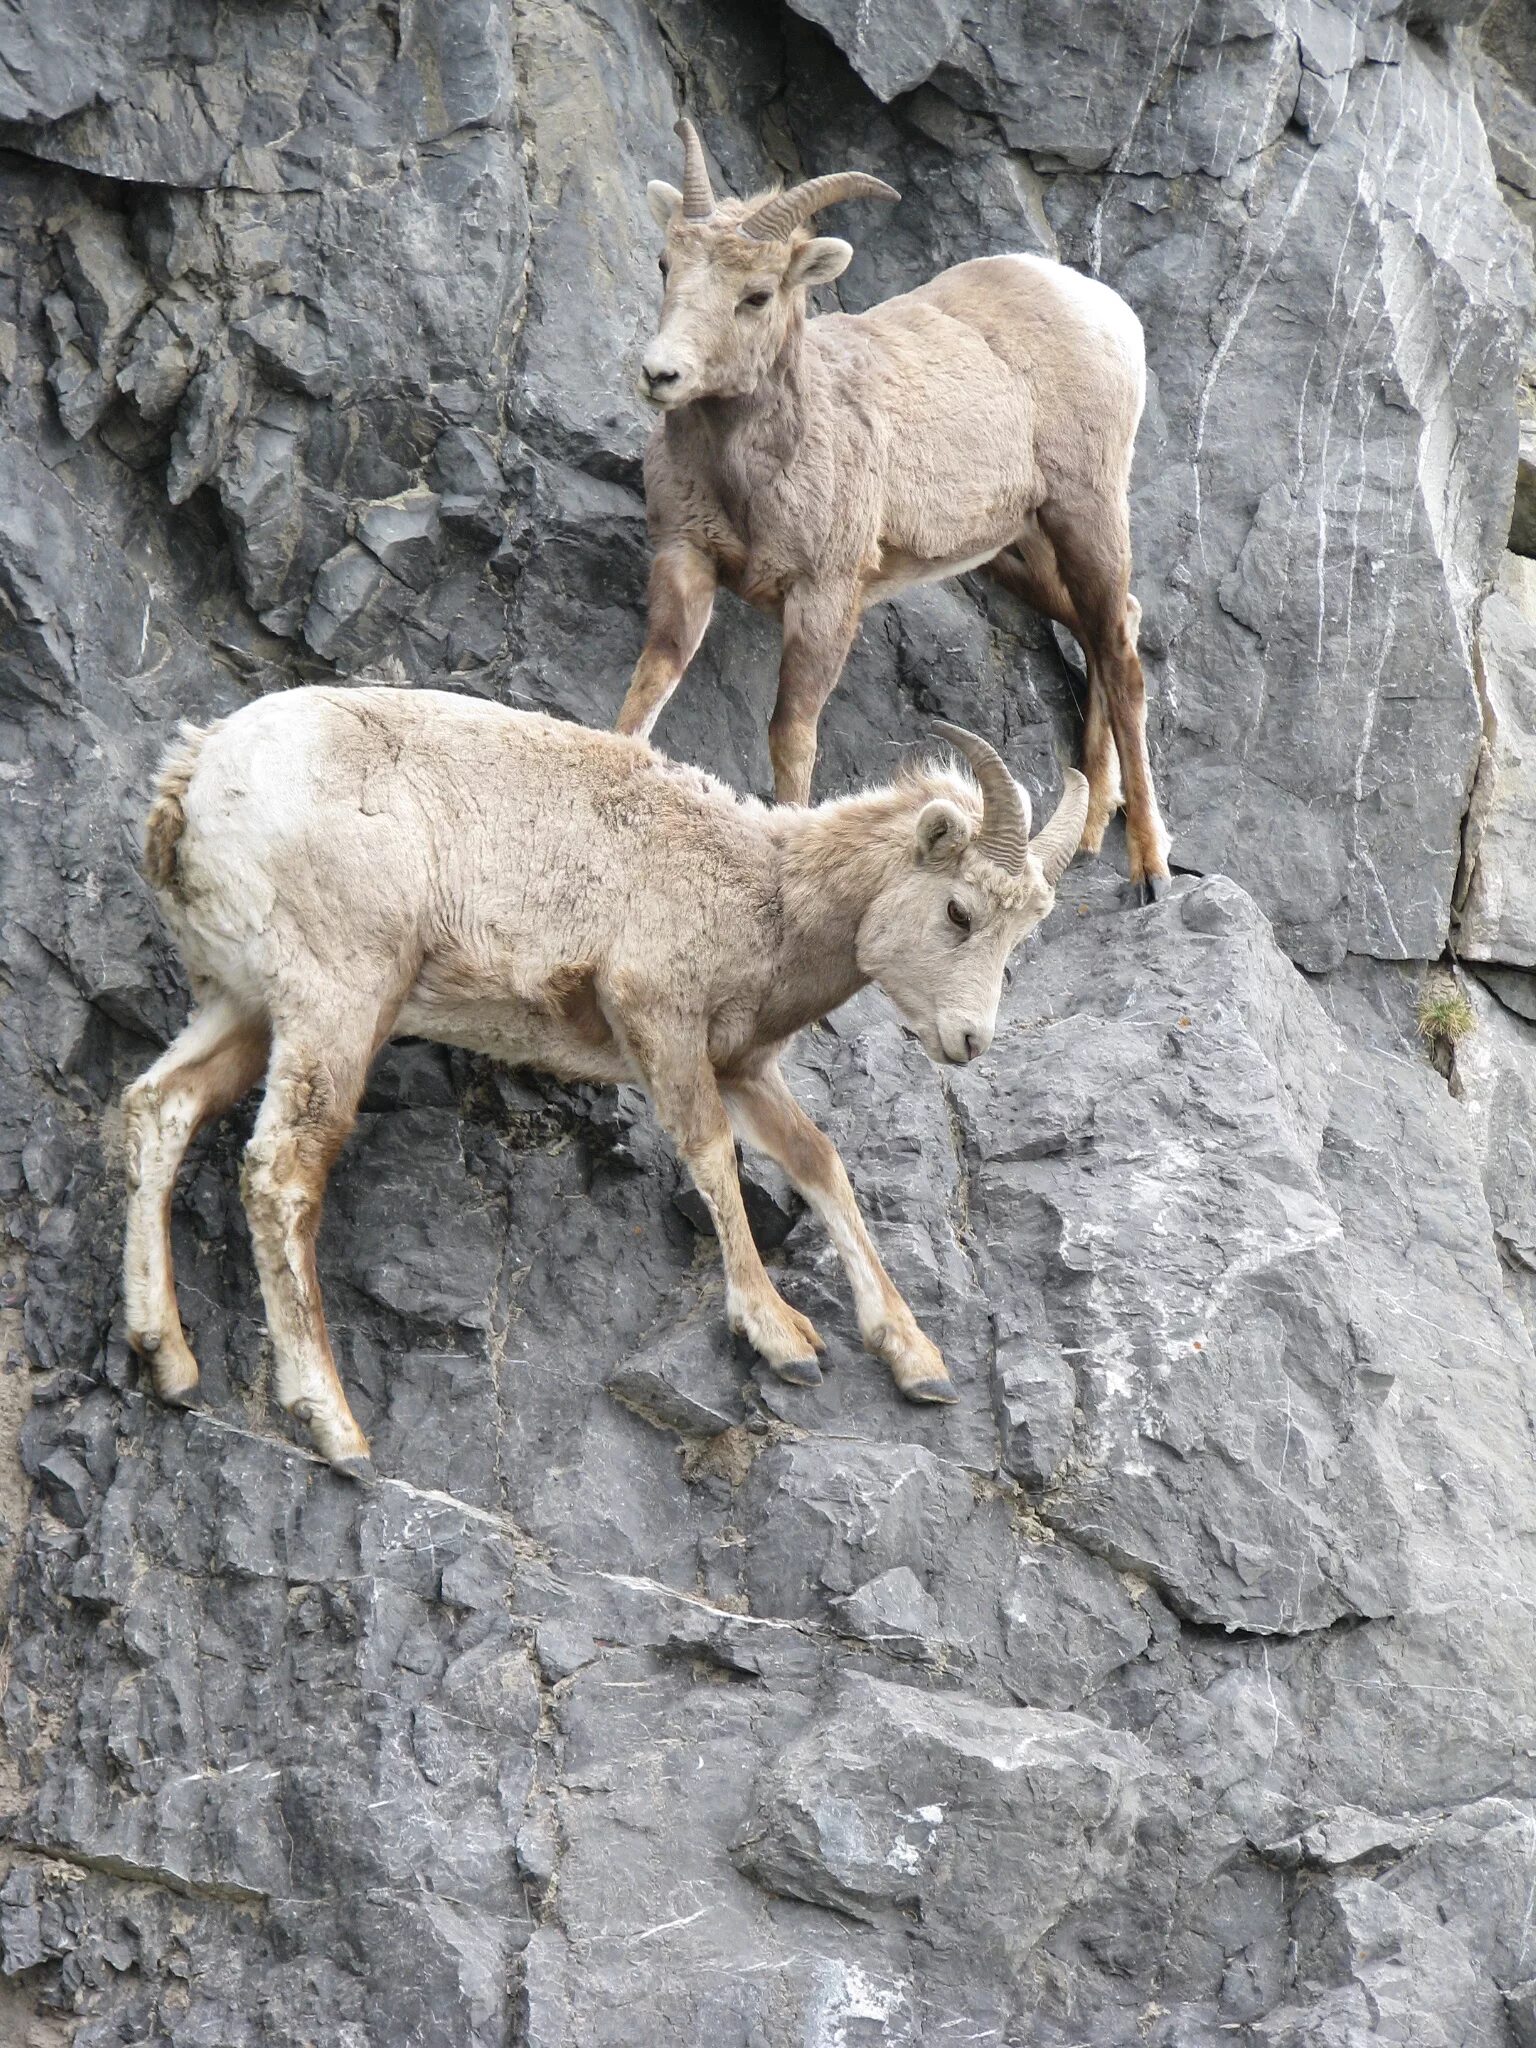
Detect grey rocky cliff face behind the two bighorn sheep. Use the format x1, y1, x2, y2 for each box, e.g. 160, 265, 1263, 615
0, 0, 1536, 2048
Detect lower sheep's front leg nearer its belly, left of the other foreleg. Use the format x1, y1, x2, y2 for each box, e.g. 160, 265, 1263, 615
618, 1016, 823, 1386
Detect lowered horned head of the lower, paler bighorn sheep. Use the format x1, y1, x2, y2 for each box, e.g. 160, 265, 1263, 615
858, 725, 1087, 1067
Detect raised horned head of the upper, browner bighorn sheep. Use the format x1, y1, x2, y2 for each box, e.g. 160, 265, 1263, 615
641, 121, 899, 412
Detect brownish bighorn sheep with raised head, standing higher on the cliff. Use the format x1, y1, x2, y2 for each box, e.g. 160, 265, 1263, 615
618, 121, 1169, 889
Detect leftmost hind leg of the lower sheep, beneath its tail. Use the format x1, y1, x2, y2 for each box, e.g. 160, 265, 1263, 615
123, 997, 266, 1405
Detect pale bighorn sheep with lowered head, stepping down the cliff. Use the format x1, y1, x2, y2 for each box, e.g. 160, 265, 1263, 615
125, 686, 1087, 1477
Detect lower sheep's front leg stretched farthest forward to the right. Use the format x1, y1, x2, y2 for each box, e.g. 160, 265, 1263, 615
725, 1067, 954, 1401
